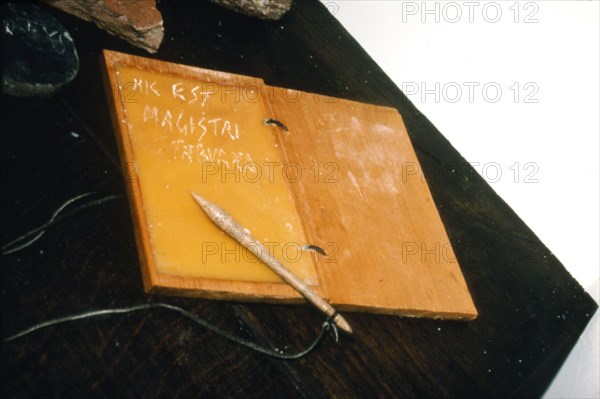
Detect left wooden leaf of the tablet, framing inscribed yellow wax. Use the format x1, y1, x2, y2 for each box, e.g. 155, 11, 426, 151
105, 51, 325, 300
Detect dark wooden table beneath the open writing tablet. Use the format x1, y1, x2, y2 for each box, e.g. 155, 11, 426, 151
1, 0, 597, 398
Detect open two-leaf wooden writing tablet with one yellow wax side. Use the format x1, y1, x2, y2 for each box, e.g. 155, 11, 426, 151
104, 51, 477, 319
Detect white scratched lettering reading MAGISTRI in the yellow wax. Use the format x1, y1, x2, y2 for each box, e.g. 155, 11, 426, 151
120, 77, 256, 173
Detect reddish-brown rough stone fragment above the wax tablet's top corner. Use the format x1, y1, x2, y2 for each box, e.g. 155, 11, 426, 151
46, 0, 165, 53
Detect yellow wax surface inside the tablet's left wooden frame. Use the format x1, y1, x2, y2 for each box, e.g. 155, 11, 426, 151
117, 66, 318, 285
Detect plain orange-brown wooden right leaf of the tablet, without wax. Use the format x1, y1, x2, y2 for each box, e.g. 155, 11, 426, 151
273, 88, 477, 319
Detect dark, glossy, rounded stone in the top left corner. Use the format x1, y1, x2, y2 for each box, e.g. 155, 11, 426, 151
0, 2, 79, 97
